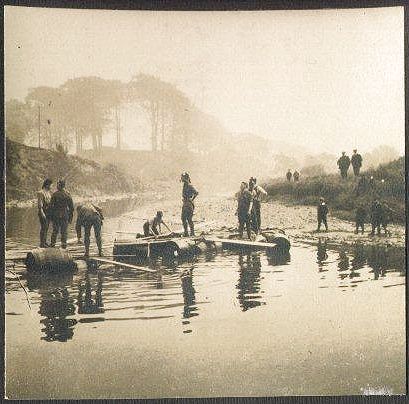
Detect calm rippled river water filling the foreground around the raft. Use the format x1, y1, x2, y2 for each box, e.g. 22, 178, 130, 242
5, 197, 405, 399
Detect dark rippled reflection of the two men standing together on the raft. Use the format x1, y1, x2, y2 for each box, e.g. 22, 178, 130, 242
236, 254, 263, 311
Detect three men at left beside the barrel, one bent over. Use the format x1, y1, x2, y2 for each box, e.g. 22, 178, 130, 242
37, 178, 104, 257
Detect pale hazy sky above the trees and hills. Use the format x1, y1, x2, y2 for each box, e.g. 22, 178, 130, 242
5, 7, 404, 154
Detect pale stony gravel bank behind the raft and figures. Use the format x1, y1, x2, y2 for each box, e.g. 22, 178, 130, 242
111, 195, 405, 251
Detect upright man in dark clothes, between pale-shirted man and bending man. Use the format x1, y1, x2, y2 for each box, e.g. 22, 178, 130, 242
50, 180, 74, 248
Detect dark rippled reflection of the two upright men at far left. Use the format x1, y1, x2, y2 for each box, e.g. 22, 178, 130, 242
39, 287, 77, 342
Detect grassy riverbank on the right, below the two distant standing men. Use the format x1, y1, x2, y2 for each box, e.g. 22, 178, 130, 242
265, 157, 405, 223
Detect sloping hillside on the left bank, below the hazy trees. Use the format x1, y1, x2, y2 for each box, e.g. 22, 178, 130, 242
6, 139, 140, 202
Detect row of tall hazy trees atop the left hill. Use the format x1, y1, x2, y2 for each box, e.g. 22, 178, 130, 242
5, 74, 226, 153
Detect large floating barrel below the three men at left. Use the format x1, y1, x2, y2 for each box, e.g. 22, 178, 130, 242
26, 248, 75, 271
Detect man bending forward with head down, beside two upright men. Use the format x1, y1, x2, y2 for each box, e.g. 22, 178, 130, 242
75, 203, 104, 257
